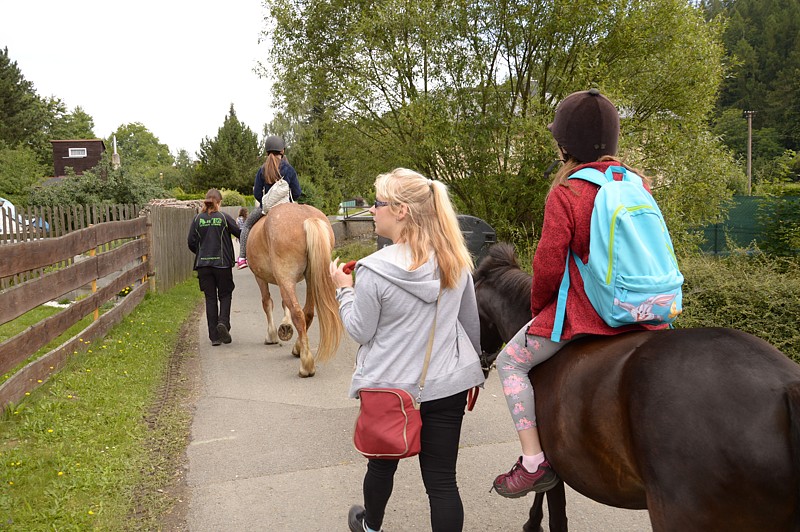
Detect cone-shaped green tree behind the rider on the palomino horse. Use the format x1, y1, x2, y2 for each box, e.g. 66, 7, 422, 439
194, 104, 263, 195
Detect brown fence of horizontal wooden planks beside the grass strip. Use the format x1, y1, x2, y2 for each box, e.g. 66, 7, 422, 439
0, 217, 150, 405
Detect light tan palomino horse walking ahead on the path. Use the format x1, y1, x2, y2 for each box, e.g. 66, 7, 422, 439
247, 203, 342, 377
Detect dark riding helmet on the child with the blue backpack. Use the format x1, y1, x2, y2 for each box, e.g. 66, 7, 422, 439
547, 89, 619, 163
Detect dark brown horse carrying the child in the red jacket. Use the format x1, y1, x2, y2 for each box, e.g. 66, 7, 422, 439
475, 244, 800, 532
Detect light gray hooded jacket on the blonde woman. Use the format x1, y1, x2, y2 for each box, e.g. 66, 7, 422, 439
337, 244, 484, 402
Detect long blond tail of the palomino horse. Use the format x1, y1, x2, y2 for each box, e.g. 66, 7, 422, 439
303, 218, 343, 362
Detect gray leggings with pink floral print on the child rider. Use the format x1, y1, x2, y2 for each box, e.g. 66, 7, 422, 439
496, 320, 567, 431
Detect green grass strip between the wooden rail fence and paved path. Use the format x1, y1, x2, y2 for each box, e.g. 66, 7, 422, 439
0, 280, 202, 531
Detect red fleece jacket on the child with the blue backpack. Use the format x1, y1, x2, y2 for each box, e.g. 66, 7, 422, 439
528, 161, 668, 341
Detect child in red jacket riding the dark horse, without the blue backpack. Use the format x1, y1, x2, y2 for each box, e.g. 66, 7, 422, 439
493, 89, 680, 498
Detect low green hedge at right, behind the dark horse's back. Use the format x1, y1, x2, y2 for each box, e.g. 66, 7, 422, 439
676, 253, 800, 362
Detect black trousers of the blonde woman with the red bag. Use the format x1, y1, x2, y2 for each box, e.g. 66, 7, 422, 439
364, 390, 467, 532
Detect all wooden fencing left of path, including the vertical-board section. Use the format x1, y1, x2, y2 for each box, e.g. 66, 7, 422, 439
0, 204, 206, 406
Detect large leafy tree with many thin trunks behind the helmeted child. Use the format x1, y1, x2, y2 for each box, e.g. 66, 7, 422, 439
264, 0, 732, 248
